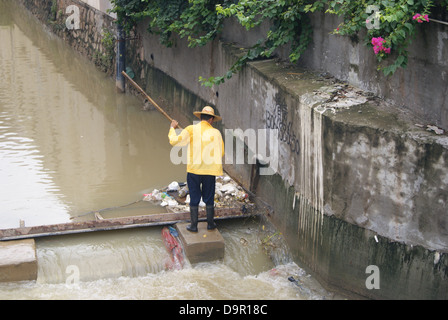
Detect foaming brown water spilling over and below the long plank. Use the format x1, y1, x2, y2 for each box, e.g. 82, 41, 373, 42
0, 221, 333, 300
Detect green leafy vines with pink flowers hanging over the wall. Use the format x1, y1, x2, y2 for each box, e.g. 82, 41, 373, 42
112, 0, 448, 87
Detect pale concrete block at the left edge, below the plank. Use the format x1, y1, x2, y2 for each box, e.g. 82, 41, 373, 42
0, 239, 37, 282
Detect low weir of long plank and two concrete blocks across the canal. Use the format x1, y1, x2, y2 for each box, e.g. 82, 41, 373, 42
0, 208, 252, 282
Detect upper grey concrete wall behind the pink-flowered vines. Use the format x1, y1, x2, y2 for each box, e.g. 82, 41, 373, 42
223, 11, 448, 130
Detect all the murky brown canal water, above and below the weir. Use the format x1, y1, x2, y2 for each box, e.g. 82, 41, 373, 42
0, 0, 333, 299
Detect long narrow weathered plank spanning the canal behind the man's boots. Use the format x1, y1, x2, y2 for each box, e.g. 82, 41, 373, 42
0, 208, 254, 240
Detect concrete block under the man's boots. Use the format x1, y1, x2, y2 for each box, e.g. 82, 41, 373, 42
176, 222, 224, 263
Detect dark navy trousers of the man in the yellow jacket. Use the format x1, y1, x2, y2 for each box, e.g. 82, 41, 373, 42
187, 172, 216, 207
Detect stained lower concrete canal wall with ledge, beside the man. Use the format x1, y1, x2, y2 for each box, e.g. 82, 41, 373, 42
15, 0, 448, 299
